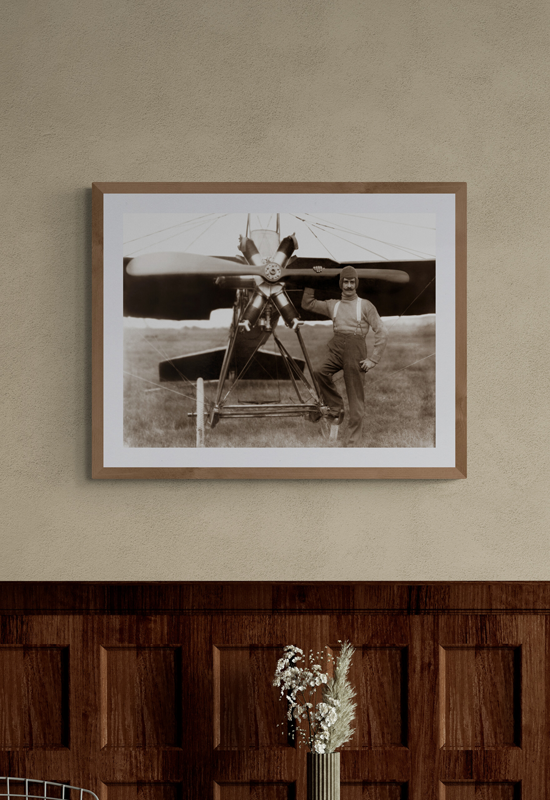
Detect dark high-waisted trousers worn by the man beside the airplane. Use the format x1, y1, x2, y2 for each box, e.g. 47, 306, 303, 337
315, 333, 367, 447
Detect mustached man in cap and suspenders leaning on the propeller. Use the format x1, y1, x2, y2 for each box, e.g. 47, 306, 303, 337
302, 267, 388, 447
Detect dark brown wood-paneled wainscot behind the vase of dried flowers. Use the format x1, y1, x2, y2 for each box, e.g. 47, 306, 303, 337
0, 583, 550, 800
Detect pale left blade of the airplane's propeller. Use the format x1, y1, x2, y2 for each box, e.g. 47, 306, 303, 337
126, 253, 263, 276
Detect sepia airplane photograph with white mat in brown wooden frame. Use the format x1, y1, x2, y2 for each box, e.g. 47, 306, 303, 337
92, 183, 466, 479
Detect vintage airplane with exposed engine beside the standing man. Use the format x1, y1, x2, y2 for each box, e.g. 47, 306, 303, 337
123, 214, 435, 441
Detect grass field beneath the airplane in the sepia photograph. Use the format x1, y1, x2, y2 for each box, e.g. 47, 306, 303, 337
124, 317, 435, 447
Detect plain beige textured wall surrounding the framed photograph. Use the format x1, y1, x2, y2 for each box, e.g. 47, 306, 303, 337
0, 0, 550, 580
